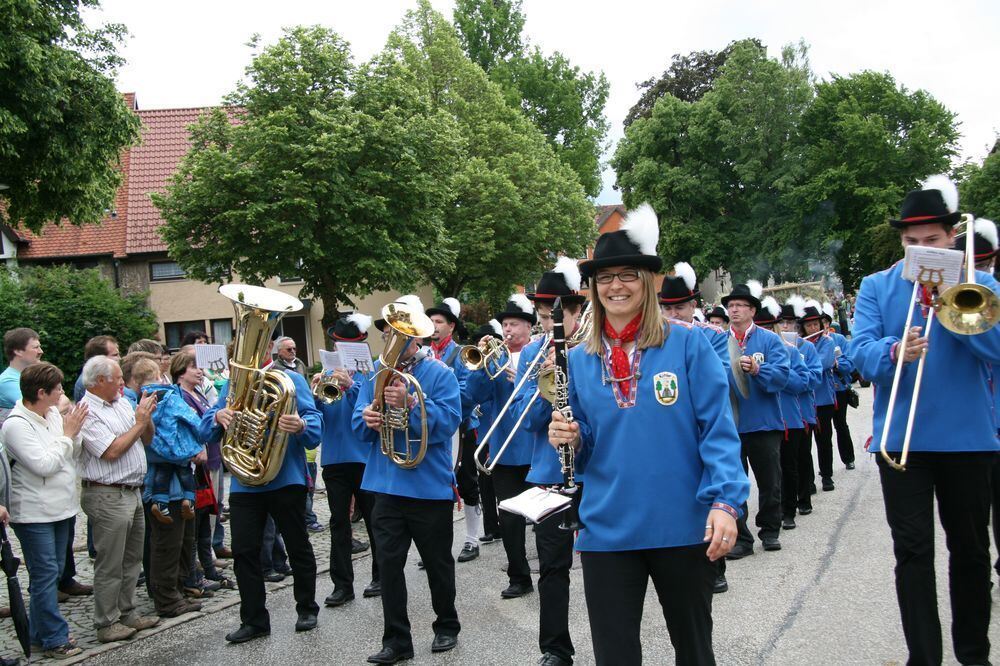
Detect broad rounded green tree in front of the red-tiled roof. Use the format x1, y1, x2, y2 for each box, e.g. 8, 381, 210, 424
154, 26, 461, 326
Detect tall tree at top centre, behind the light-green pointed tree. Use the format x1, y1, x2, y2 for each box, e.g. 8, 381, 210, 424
453, 0, 609, 196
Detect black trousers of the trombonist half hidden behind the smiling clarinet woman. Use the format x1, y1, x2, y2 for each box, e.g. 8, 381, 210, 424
535, 506, 575, 661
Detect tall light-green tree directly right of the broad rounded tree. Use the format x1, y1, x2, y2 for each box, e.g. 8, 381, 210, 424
389, 2, 594, 302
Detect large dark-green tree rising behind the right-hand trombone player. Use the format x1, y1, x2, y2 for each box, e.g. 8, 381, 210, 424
786, 71, 958, 289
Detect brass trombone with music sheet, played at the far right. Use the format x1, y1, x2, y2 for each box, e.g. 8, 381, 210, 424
879, 214, 1000, 472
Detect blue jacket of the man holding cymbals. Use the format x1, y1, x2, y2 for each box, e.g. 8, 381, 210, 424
728, 324, 789, 436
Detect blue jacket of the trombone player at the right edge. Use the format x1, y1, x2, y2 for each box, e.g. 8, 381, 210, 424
848, 262, 1000, 452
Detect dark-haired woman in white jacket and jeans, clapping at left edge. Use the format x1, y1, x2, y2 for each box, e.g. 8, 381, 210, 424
0, 363, 87, 659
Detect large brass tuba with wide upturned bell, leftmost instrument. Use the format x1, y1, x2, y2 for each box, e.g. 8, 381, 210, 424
219, 284, 302, 486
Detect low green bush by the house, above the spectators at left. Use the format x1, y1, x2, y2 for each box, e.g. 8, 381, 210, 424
0, 266, 157, 388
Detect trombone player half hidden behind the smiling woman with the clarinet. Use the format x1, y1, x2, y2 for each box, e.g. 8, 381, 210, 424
505, 257, 586, 666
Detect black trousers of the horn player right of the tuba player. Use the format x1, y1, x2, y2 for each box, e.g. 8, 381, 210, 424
372, 494, 462, 652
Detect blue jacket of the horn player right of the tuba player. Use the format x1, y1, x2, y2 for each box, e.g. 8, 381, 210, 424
351, 357, 462, 500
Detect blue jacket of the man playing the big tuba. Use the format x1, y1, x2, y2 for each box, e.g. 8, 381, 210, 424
198, 372, 323, 493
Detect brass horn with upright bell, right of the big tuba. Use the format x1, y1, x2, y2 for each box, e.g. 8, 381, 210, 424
373, 301, 434, 469
